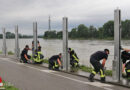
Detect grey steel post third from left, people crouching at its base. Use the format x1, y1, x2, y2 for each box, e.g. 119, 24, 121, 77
33, 22, 37, 56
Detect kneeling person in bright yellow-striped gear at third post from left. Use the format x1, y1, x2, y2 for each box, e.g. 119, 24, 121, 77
33, 46, 44, 64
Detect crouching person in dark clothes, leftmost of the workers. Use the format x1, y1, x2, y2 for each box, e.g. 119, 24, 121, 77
21, 45, 31, 63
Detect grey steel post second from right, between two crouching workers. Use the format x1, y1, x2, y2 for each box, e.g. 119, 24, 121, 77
63, 17, 70, 71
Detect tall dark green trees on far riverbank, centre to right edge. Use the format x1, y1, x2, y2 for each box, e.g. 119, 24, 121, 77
43, 20, 130, 39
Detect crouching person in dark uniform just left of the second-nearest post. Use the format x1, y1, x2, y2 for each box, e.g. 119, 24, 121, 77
49, 53, 62, 70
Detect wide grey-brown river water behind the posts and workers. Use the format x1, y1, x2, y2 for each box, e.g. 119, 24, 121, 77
0, 39, 130, 69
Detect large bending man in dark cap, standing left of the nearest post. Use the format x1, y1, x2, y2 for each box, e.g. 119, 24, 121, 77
89, 49, 109, 83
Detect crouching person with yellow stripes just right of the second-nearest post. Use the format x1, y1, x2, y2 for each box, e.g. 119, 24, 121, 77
69, 48, 79, 67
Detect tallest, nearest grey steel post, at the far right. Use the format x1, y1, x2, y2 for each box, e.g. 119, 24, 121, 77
113, 9, 122, 82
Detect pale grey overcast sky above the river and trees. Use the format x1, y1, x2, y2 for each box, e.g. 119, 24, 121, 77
0, 0, 130, 34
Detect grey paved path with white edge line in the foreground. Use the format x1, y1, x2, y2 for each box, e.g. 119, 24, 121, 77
0, 57, 130, 90
